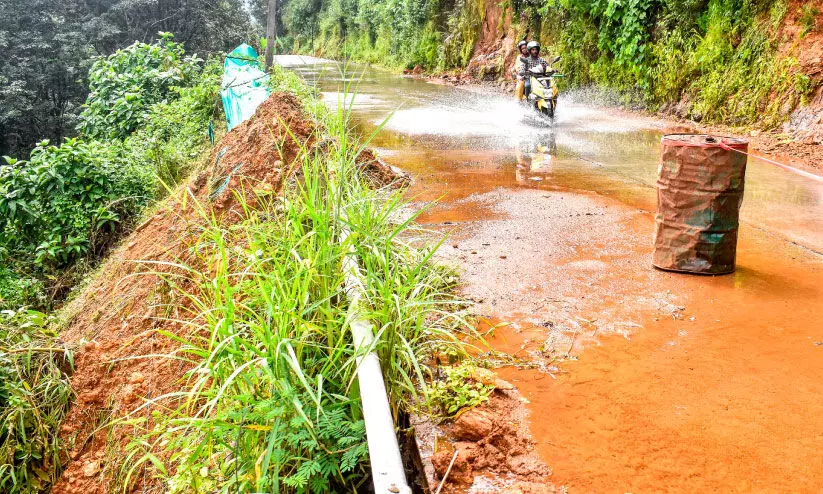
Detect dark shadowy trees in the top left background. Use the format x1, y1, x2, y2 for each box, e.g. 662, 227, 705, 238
0, 0, 263, 158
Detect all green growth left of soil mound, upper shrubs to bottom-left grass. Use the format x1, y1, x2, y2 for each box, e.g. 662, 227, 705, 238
0, 34, 220, 493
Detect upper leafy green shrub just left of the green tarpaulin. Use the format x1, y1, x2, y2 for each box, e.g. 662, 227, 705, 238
78, 33, 201, 139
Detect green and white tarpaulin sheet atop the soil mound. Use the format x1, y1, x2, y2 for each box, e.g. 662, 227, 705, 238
220, 43, 271, 130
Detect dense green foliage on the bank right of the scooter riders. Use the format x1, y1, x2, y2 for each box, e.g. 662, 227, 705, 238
536, 0, 813, 127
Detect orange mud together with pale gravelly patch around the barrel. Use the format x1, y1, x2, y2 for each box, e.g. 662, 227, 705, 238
428, 176, 823, 492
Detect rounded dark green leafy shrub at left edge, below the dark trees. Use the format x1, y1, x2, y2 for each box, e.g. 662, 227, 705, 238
0, 139, 153, 272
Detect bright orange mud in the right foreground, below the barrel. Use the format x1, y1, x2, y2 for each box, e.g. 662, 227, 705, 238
500, 223, 823, 492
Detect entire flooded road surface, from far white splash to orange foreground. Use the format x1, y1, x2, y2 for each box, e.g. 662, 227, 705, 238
281, 57, 823, 492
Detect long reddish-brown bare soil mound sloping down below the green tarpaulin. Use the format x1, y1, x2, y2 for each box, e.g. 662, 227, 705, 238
53, 93, 396, 494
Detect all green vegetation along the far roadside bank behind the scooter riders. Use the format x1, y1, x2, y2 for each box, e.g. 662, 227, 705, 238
283, 0, 819, 128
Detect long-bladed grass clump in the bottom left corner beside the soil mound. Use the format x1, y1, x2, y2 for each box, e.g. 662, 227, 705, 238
0, 311, 72, 494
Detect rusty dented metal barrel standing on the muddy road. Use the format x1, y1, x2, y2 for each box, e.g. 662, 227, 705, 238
652, 134, 748, 274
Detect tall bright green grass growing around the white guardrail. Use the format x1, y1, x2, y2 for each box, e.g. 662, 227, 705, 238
122, 86, 465, 492
